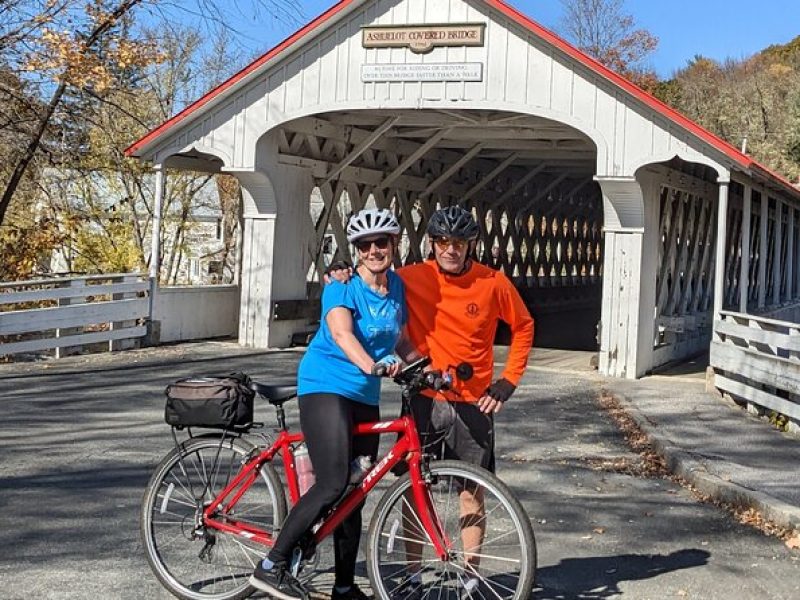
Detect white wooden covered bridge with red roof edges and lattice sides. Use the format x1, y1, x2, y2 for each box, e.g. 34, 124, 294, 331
123, 0, 800, 378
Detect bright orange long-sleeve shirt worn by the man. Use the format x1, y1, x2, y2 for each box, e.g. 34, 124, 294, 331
397, 260, 533, 402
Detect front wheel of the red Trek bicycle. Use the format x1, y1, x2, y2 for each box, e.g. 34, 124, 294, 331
367, 461, 536, 600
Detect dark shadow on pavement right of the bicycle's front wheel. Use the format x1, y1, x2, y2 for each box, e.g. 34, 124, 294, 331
533, 548, 710, 600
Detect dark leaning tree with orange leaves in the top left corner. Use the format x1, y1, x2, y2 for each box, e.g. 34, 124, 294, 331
0, 0, 300, 224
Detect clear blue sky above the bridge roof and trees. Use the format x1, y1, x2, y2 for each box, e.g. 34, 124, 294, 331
228, 0, 800, 78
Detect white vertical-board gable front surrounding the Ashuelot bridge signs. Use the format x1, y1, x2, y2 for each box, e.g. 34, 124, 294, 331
141, 0, 720, 175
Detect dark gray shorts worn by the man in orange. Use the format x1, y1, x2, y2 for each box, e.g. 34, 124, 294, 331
411, 395, 495, 473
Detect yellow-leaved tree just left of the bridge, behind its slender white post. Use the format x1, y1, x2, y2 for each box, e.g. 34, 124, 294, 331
30, 27, 240, 283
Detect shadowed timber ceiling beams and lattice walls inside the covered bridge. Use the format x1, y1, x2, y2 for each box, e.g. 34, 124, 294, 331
277, 110, 603, 300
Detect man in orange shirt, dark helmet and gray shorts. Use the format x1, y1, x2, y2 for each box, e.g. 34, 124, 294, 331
333, 206, 534, 597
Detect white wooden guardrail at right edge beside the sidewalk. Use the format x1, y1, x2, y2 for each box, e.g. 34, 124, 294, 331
710, 311, 800, 422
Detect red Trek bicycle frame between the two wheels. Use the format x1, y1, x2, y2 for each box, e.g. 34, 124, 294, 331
203, 415, 451, 560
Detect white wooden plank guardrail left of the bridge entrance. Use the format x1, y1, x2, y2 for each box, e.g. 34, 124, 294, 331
0, 273, 150, 357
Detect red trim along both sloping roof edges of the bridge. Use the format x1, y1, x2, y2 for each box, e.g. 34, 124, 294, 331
125, 0, 800, 193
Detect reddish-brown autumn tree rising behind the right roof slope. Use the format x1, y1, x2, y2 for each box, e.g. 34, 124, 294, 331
561, 0, 658, 90
